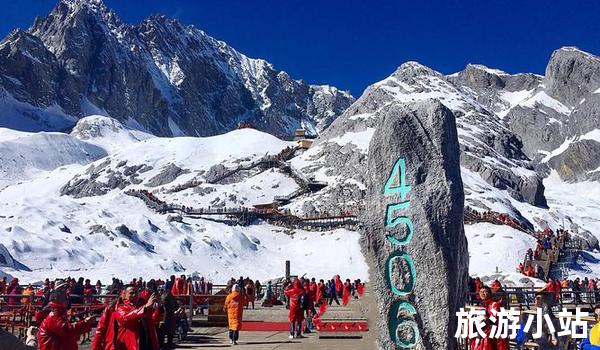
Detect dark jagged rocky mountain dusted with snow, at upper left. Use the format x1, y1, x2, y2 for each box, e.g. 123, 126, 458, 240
0, 0, 353, 136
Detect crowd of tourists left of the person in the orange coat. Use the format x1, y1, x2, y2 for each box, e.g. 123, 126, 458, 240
0, 275, 213, 350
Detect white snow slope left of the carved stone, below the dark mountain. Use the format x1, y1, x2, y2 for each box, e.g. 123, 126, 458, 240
0, 117, 367, 283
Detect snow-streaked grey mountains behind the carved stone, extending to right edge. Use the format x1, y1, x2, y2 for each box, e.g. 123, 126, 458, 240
289, 47, 600, 284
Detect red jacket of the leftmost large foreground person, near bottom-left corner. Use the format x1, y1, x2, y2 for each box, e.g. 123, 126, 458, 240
38, 303, 91, 350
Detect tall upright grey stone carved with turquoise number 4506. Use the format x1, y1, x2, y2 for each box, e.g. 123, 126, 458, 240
361, 100, 469, 350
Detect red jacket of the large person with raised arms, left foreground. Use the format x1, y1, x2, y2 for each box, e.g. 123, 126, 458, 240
114, 301, 161, 350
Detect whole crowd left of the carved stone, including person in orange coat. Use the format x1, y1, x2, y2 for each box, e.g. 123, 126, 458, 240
0, 275, 364, 350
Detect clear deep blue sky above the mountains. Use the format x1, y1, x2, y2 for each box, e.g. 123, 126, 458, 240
0, 0, 600, 96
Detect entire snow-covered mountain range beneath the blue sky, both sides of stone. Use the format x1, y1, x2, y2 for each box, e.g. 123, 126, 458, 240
0, 0, 600, 288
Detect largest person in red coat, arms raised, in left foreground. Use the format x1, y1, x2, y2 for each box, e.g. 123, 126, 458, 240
114, 286, 161, 350
